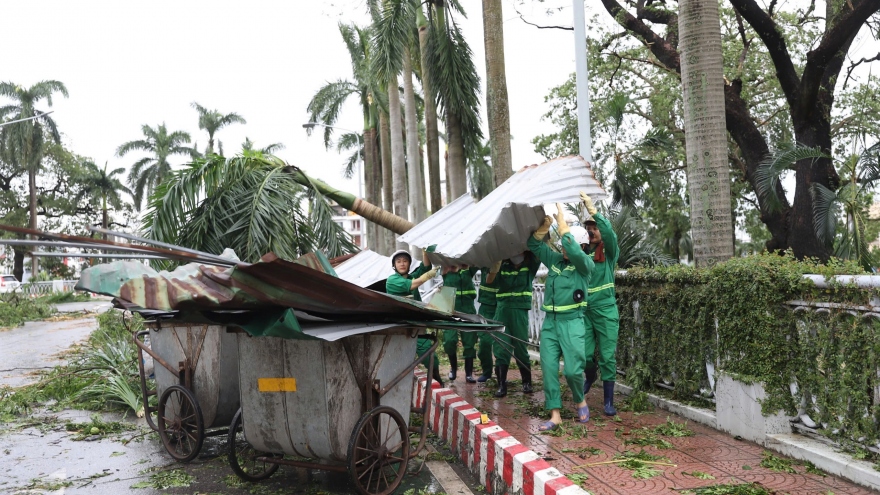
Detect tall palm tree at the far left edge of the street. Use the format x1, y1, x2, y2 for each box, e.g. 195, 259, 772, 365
0, 80, 67, 276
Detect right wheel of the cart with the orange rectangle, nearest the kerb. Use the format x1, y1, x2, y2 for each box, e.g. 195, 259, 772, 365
348, 406, 409, 495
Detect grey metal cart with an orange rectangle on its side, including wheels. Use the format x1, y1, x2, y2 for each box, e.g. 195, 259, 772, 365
228, 325, 437, 495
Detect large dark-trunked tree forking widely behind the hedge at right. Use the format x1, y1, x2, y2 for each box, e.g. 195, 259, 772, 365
602, 0, 880, 259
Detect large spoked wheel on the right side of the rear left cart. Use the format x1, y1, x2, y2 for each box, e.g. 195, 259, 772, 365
157, 385, 205, 462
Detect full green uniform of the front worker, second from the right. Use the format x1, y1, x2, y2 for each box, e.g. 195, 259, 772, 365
528, 232, 595, 410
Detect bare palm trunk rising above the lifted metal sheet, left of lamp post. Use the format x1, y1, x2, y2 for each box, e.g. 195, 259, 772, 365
483, 0, 513, 186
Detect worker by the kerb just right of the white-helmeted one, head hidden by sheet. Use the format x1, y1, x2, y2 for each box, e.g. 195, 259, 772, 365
443, 265, 477, 383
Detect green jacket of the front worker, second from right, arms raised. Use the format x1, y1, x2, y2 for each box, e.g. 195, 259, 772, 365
528, 233, 594, 318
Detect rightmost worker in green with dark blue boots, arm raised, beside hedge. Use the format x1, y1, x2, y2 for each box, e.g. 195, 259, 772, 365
581, 192, 620, 416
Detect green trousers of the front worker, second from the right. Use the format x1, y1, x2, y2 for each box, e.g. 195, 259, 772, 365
541, 313, 595, 411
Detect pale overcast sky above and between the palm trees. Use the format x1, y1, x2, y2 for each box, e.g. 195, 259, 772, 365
0, 0, 592, 203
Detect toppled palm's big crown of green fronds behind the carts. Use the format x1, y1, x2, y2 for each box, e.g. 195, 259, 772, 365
144, 151, 357, 263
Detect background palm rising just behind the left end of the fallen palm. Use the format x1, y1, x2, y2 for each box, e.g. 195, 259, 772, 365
116, 122, 193, 210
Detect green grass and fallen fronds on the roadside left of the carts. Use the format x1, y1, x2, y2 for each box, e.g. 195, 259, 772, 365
0, 311, 141, 422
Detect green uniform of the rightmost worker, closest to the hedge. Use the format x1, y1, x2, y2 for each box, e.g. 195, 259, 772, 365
586, 213, 620, 382
